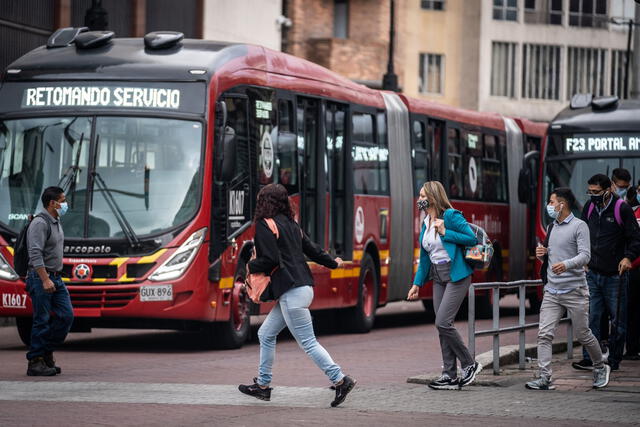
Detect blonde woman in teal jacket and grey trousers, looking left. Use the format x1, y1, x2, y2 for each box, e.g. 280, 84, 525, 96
407, 181, 482, 390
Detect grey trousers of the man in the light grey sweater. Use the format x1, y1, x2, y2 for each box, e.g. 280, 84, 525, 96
538, 286, 604, 379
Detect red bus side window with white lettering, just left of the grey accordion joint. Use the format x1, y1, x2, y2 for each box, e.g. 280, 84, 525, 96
351, 113, 380, 194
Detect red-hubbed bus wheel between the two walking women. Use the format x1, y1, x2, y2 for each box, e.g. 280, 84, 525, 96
345, 254, 379, 333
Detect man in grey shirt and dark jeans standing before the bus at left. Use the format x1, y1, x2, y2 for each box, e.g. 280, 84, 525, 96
25, 187, 73, 376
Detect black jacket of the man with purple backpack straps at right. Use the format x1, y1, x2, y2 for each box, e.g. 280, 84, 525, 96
582, 195, 640, 276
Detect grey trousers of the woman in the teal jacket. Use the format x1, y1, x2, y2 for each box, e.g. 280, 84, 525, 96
431, 263, 474, 378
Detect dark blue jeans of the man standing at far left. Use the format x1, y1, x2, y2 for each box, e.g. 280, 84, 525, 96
27, 270, 73, 360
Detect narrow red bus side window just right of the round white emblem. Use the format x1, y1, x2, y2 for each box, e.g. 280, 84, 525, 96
274, 99, 299, 194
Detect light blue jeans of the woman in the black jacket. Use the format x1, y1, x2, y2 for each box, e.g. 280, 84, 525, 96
258, 286, 344, 386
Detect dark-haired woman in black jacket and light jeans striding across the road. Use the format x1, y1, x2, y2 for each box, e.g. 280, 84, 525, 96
238, 184, 356, 407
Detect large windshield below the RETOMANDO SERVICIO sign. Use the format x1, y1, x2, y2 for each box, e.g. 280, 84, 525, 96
0, 116, 203, 238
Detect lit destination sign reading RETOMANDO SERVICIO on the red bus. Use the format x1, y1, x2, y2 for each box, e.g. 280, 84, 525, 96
0, 81, 206, 113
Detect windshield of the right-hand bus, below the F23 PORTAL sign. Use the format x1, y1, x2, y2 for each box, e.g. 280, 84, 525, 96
541, 134, 640, 227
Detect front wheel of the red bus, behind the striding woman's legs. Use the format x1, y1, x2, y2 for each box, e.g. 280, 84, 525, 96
209, 282, 251, 349
